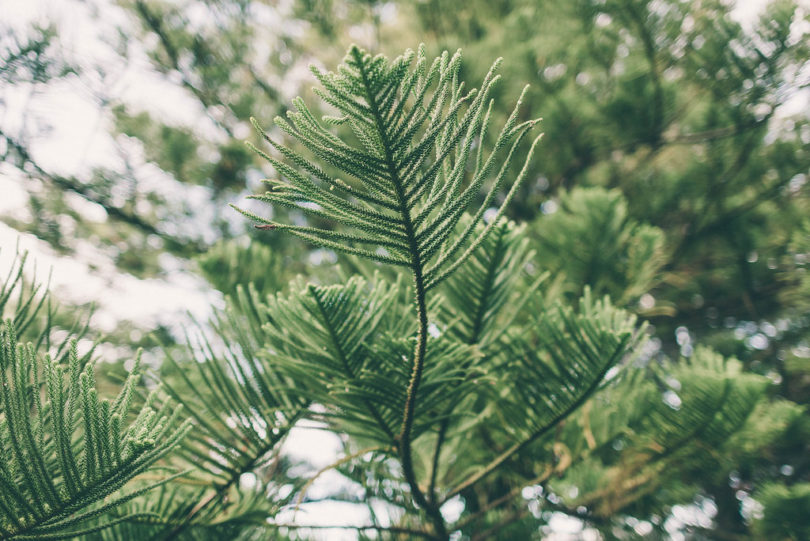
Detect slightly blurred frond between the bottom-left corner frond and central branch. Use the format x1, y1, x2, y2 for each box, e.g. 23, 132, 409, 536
158, 286, 307, 535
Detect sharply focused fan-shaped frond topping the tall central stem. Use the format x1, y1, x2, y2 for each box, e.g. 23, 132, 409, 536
241, 46, 538, 289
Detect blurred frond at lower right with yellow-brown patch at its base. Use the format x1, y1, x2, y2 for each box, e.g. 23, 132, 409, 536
556, 348, 767, 517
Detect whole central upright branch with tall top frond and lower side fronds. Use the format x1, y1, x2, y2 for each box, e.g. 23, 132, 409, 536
230, 43, 652, 539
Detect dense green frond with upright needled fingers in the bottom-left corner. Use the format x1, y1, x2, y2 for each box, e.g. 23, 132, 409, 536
0, 322, 189, 539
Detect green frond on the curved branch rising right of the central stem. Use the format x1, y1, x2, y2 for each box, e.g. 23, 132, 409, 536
499, 290, 638, 439
